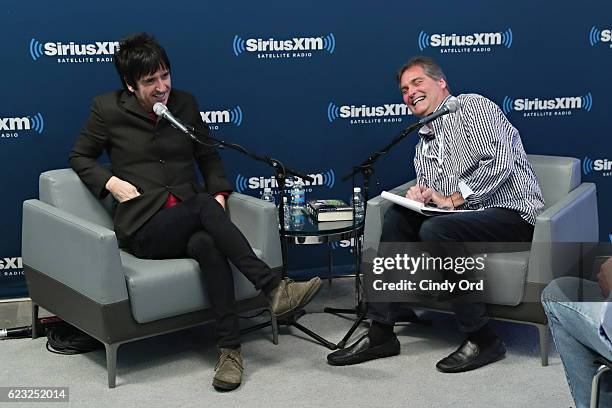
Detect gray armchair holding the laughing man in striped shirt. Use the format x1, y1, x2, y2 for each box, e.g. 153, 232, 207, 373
364, 155, 599, 366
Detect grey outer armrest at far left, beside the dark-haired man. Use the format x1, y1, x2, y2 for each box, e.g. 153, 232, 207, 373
21, 200, 128, 304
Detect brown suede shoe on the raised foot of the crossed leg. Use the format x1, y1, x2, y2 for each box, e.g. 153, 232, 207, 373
270, 277, 321, 318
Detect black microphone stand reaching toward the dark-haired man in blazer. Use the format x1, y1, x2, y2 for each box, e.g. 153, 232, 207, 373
186, 127, 336, 350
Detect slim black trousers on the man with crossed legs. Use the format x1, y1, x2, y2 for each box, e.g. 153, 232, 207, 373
130, 193, 281, 347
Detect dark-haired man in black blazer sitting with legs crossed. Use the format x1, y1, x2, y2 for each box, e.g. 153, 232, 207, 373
70, 34, 321, 390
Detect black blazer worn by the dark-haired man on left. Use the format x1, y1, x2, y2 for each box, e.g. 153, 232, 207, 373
69, 90, 232, 245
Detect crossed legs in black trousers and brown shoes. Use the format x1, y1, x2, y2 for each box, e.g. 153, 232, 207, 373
131, 194, 321, 390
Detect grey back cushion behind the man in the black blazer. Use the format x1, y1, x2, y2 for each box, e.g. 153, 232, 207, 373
38, 169, 114, 230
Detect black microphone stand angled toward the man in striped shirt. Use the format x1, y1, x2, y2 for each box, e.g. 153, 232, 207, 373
323, 120, 430, 349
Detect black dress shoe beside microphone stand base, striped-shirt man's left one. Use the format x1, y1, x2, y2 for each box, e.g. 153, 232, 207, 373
327, 334, 400, 365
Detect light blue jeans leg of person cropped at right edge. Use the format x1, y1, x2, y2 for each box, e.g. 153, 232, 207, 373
542, 277, 612, 408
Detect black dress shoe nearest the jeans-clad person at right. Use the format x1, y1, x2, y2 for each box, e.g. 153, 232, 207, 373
436, 337, 506, 373
